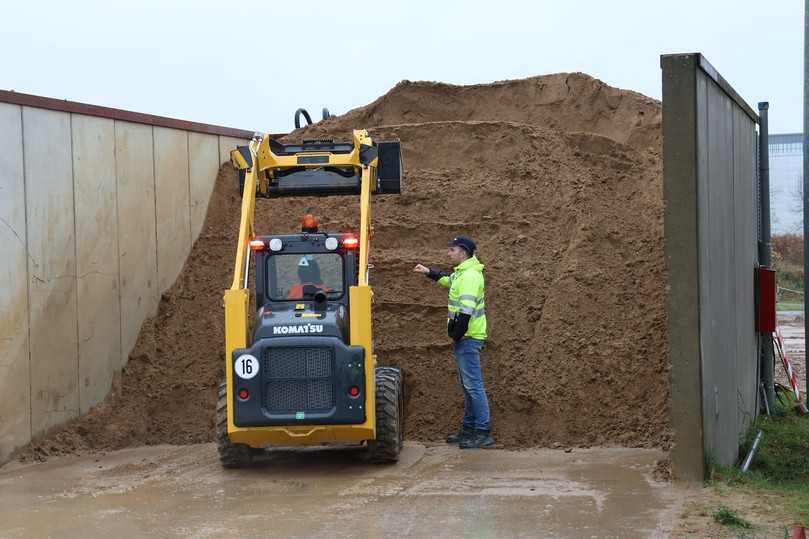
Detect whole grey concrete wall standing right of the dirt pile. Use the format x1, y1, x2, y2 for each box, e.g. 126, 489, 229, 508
662, 54, 759, 481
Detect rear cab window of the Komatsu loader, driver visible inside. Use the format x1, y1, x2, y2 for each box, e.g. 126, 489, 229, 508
266, 253, 344, 301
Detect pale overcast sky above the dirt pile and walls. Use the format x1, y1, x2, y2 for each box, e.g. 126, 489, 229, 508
0, 0, 803, 133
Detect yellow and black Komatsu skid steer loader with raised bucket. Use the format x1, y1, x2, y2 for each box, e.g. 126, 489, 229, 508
216, 123, 404, 467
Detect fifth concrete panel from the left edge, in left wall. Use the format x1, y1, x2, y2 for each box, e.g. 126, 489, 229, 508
154, 127, 191, 292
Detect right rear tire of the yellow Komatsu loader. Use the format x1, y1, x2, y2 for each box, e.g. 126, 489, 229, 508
367, 367, 404, 464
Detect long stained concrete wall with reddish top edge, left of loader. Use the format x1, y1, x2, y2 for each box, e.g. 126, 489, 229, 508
0, 93, 245, 463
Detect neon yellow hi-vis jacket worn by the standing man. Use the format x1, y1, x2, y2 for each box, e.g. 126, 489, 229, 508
438, 256, 486, 340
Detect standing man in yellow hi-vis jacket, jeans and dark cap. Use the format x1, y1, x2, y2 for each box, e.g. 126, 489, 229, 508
413, 236, 494, 449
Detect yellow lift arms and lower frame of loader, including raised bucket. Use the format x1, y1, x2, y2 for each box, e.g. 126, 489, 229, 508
224, 130, 402, 448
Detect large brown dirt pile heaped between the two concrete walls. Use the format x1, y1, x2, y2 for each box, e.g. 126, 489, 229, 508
23, 70, 669, 457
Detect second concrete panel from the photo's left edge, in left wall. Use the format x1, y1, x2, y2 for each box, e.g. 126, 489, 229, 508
23, 107, 79, 436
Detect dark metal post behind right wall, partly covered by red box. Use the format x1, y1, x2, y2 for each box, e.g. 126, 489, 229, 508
758, 101, 776, 410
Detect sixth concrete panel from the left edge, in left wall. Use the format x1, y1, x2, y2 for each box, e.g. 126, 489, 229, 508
188, 133, 219, 242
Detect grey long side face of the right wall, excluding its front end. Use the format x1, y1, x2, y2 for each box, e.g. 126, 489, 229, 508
697, 71, 758, 465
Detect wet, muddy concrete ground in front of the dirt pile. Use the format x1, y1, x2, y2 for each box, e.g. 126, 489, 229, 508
0, 443, 685, 538
